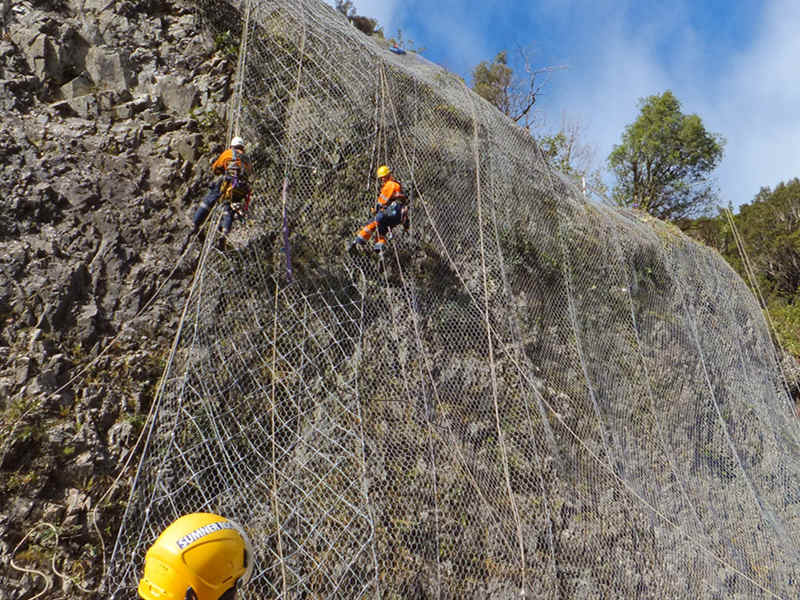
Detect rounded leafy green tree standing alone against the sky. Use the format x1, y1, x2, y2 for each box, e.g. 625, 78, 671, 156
608, 90, 725, 220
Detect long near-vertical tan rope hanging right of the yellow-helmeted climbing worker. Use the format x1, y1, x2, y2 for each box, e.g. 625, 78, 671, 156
462, 82, 527, 595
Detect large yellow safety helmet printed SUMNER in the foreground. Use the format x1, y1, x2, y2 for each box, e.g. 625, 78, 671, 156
139, 513, 253, 600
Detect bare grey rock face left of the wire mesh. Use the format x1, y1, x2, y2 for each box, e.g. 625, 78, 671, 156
0, 0, 235, 600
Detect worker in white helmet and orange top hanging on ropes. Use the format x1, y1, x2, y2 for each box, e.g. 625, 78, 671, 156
190, 135, 253, 235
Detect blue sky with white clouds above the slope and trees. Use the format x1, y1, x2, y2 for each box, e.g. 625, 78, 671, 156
331, 0, 800, 207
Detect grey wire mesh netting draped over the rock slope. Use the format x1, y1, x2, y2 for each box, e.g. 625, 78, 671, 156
106, 0, 800, 599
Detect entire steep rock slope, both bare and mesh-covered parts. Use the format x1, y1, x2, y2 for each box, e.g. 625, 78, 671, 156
6, 0, 798, 600
